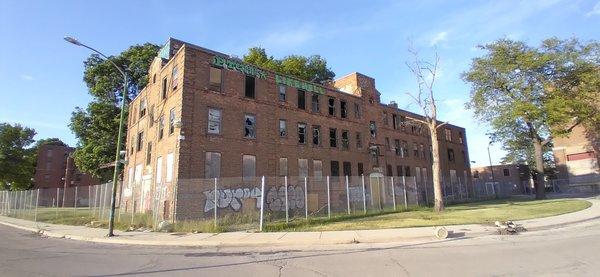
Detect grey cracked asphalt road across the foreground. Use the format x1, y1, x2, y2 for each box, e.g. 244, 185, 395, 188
0, 220, 600, 277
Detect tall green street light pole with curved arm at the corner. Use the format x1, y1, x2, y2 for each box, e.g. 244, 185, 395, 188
64, 37, 127, 237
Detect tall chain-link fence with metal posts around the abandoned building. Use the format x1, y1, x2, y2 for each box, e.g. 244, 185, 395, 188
0, 175, 498, 232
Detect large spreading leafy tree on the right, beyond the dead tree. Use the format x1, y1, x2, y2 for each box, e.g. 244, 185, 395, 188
462, 39, 598, 199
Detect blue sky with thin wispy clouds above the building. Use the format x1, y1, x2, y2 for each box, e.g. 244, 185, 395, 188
0, 0, 600, 165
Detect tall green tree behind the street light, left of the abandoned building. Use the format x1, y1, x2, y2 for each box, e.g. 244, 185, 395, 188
69, 43, 159, 179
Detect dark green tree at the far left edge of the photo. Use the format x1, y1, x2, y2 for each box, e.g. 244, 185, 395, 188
0, 123, 35, 190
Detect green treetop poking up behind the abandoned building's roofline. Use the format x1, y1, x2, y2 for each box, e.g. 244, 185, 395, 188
244, 47, 335, 82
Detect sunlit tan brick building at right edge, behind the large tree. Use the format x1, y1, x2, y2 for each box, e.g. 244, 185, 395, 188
553, 126, 600, 191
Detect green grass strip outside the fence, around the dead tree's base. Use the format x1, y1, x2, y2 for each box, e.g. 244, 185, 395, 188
266, 199, 592, 231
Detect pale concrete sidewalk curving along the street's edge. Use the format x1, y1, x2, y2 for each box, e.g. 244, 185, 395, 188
0, 198, 600, 248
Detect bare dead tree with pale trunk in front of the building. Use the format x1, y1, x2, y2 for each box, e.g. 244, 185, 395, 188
406, 47, 447, 212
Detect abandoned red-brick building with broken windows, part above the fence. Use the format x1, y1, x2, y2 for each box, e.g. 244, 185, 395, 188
121, 39, 471, 219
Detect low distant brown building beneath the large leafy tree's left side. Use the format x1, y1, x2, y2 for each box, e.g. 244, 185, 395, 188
471, 164, 533, 196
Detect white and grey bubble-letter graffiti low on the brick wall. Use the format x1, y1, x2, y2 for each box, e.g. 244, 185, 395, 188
202, 185, 304, 212
